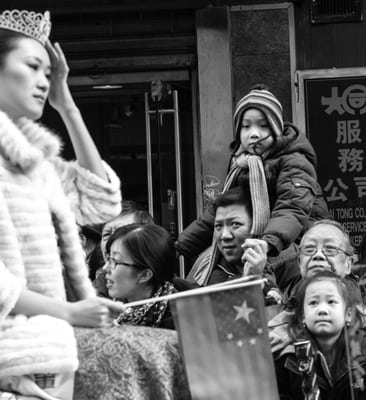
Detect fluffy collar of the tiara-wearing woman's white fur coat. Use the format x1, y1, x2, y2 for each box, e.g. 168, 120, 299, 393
0, 111, 61, 173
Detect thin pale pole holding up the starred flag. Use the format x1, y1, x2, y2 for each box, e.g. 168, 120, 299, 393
116, 275, 267, 308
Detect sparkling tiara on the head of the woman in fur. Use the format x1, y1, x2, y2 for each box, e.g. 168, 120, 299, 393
0, 10, 51, 45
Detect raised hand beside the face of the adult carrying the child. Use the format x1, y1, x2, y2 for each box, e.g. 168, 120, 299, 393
241, 239, 268, 276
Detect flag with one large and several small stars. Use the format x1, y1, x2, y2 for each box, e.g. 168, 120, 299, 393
172, 281, 279, 400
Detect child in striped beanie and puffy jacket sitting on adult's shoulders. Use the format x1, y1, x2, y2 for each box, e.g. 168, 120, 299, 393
176, 86, 328, 278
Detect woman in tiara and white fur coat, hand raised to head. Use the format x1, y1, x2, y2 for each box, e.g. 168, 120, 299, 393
0, 10, 128, 399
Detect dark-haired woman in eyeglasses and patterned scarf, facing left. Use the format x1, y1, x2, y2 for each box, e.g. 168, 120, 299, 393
103, 224, 176, 329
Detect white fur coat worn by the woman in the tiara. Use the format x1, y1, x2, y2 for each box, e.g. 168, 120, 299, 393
0, 111, 121, 376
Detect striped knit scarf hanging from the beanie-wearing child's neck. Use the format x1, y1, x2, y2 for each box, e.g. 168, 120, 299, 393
194, 153, 271, 285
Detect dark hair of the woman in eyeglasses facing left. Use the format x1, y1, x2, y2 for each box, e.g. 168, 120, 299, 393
106, 224, 176, 288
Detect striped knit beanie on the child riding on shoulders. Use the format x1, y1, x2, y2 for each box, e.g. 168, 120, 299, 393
234, 89, 283, 138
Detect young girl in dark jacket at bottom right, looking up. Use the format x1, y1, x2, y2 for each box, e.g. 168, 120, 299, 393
276, 272, 366, 400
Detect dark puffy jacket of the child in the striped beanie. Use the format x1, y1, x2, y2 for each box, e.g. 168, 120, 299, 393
176, 123, 329, 256
